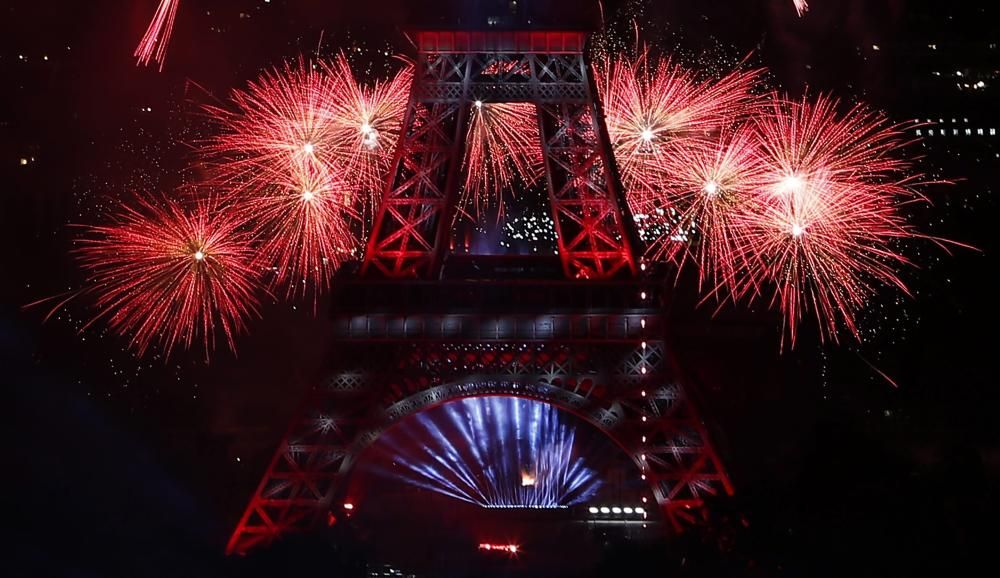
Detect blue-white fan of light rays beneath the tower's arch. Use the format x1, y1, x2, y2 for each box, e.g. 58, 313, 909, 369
370, 397, 601, 508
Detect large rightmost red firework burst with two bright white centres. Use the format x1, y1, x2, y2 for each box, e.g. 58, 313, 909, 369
734, 95, 922, 346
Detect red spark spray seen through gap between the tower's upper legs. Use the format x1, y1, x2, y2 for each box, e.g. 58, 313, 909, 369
462, 100, 544, 216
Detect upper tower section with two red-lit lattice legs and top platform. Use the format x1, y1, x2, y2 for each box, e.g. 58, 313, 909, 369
362, 31, 637, 279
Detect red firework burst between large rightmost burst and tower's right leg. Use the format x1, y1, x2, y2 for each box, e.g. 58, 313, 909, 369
652, 128, 765, 293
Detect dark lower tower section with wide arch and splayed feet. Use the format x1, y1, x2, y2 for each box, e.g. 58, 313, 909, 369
228, 279, 732, 553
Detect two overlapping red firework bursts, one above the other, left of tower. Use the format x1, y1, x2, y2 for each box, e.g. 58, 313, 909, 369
202, 62, 359, 298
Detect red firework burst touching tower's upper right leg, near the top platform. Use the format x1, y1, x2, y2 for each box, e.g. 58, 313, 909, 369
595, 53, 760, 205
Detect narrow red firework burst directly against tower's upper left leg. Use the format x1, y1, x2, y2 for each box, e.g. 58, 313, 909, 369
324, 54, 413, 210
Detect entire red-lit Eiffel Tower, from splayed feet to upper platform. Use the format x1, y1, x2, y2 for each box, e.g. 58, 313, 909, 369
227, 32, 732, 553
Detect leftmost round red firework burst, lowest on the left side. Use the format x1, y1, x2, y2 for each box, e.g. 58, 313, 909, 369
78, 196, 260, 357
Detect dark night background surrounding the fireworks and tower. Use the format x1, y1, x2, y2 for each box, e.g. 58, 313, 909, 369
0, 0, 1000, 576
